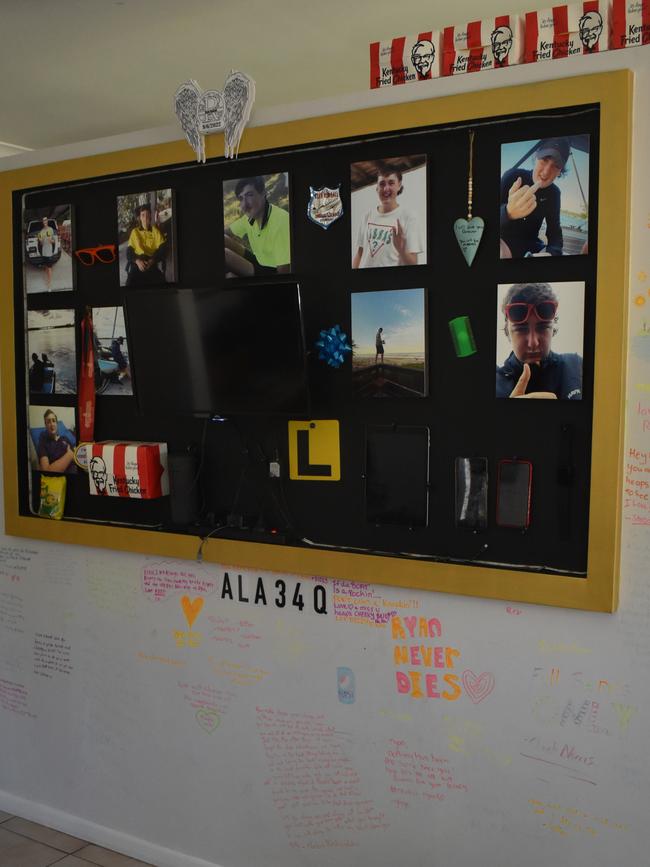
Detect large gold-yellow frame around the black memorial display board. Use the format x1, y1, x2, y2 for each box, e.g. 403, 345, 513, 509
0, 70, 632, 611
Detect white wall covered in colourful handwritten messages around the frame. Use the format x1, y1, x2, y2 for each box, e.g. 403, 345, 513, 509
0, 49, 650, 867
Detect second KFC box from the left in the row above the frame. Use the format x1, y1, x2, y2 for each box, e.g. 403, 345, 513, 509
442, 15, 523, 75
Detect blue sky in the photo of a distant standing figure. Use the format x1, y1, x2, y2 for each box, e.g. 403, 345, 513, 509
352, 289, 425, 356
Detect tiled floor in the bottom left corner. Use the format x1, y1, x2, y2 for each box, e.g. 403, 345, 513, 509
0, 810, 152, 867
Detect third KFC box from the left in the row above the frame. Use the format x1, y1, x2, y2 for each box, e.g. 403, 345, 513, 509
524, 0, 609, 63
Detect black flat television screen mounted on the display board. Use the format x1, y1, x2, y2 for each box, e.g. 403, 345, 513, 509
125, 283, 309, 416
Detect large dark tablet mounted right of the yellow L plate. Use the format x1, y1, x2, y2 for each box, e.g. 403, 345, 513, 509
364, 425, 430, 527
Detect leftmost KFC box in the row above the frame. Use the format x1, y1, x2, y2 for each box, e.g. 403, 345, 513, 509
370, 30, 440, 90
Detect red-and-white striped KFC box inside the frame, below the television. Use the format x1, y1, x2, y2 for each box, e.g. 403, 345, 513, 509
88, 442, 169, 500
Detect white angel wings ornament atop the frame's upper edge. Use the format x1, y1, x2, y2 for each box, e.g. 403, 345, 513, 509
174, 69, 255, 163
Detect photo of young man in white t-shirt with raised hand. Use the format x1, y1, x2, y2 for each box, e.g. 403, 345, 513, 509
352, 156, 426, 269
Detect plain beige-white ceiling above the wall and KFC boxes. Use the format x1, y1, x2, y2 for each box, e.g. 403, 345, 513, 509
0, 0, 536, 156
